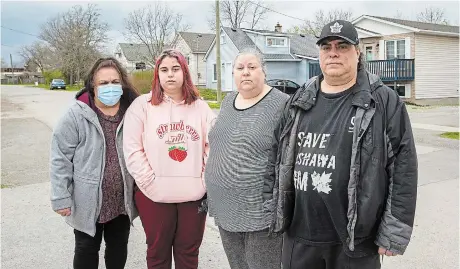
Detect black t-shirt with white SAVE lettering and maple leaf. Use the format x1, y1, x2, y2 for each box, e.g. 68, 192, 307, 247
288, 82, 356, 245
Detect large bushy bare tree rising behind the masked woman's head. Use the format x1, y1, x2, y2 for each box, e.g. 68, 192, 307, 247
40, 4, 109, 84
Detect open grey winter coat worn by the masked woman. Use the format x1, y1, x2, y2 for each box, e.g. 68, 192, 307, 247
50, 93, 138, 236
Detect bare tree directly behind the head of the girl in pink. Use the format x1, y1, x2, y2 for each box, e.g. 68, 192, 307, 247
123, 2, 190, 67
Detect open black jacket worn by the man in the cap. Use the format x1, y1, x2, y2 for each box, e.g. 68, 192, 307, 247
264, 70, 417, 254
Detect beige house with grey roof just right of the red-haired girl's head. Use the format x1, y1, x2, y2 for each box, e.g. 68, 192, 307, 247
175, 32, 215, 86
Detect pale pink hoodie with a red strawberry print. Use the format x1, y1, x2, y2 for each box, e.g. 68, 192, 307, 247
123, 93, 216, 203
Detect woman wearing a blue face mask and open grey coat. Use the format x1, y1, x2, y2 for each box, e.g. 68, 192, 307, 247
50, 58, 139, 269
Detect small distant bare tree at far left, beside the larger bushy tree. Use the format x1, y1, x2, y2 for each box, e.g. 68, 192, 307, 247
19, 41, 53, 74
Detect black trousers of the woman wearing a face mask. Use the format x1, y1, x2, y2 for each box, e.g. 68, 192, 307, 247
73, 215, 130, 269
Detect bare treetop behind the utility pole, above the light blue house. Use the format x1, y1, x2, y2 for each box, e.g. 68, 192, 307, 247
208, 0, 269, 31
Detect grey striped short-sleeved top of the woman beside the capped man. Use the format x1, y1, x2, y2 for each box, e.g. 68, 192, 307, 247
205, 88, 289, 232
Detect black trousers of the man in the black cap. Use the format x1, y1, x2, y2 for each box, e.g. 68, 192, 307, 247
282, 233, 380, 269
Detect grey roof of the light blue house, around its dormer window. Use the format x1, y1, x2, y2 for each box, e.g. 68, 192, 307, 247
222, 27, 318, 60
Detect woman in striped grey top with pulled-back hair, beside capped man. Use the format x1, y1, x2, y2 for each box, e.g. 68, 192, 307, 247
205, 50, 288, 269
